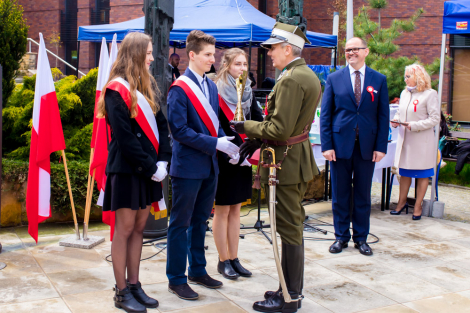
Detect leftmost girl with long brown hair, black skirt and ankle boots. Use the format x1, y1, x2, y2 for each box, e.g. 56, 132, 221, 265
97, 32, 171, 312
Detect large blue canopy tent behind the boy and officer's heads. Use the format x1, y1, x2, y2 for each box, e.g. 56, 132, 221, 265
78, 0, 337, 49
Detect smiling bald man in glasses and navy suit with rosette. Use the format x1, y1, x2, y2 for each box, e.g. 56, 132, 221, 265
320, 37, 390, 255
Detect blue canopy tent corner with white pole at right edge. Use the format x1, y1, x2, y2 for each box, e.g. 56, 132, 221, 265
429, 0, 470, 216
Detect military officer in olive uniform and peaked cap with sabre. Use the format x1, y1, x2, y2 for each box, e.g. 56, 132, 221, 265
232, 22, 321, 312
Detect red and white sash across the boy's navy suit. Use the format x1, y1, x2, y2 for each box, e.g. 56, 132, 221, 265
170, 75, 219, 137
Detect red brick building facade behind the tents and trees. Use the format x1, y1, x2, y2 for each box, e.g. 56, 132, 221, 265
19, 0, 449, 103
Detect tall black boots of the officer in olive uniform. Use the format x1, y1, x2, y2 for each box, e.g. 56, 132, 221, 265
253, 243, 304, 313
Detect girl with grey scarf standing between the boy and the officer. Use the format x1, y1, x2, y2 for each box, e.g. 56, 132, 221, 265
212, 48, 263, 279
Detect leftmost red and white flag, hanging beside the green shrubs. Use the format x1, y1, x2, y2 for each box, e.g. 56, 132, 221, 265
26, 33, 65, 243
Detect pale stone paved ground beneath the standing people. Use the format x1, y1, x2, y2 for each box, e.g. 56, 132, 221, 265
0, 200, 470, 313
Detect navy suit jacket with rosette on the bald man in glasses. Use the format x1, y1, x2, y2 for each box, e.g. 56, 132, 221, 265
320, 66, 390, 160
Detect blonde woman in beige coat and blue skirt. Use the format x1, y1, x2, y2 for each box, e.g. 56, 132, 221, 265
390, 64, 441, 220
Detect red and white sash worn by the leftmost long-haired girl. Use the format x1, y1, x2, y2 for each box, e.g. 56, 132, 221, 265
106, 77, 166, 212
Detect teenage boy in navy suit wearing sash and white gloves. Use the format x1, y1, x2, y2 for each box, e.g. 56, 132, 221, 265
166, 30, 238, 300
